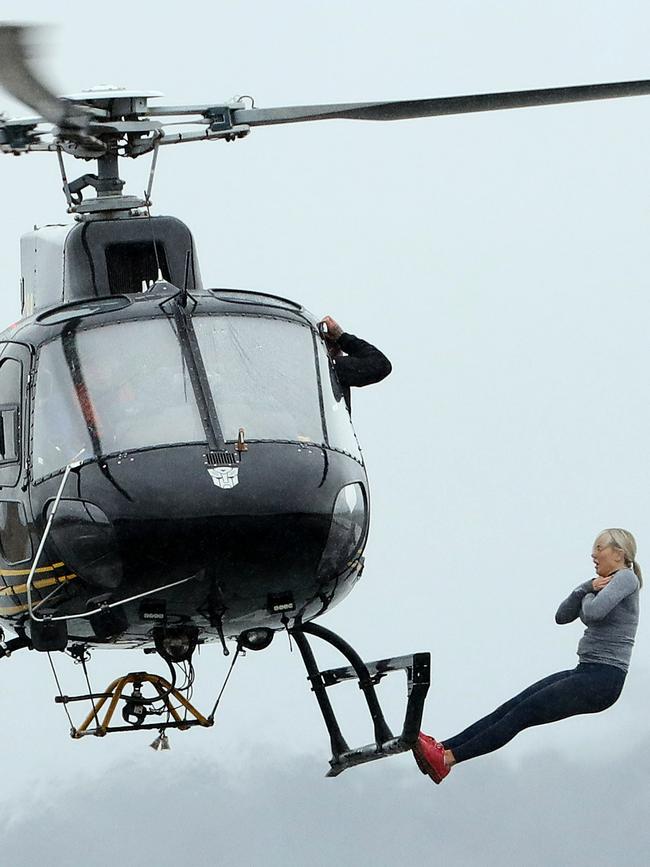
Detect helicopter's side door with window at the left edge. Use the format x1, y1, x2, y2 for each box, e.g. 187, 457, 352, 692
0, 344, 32, 572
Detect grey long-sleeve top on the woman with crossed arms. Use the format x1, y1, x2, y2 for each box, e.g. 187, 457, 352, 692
555, 569, 640, 671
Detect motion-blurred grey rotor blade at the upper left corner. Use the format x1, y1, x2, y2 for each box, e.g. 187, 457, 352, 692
0, 24, 91, 129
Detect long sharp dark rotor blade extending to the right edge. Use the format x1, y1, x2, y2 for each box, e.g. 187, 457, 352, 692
233, 80, 650, 126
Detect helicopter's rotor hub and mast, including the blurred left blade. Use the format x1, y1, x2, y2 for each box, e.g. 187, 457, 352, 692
0, 37, 249, 220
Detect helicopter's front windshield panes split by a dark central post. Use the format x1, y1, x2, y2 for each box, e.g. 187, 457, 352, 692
32, 299, 360, 481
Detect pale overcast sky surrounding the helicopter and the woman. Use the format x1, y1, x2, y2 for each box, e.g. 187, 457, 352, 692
0, 0, 650, 867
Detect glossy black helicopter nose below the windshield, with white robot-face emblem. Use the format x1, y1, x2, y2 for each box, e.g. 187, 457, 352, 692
46, 443, 365, 593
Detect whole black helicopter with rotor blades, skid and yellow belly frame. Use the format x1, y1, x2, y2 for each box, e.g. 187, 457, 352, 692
0, 25, 650, 776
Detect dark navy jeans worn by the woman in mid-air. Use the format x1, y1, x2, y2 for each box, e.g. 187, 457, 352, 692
443, 662, 625, 762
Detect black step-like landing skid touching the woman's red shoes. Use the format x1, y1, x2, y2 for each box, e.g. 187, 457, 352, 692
290, 623, 431, 777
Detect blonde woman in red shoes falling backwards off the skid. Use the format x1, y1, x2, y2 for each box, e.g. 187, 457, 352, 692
413, 528, 642, 783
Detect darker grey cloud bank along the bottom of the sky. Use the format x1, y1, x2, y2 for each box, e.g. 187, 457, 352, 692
2, 739, 650, 867
